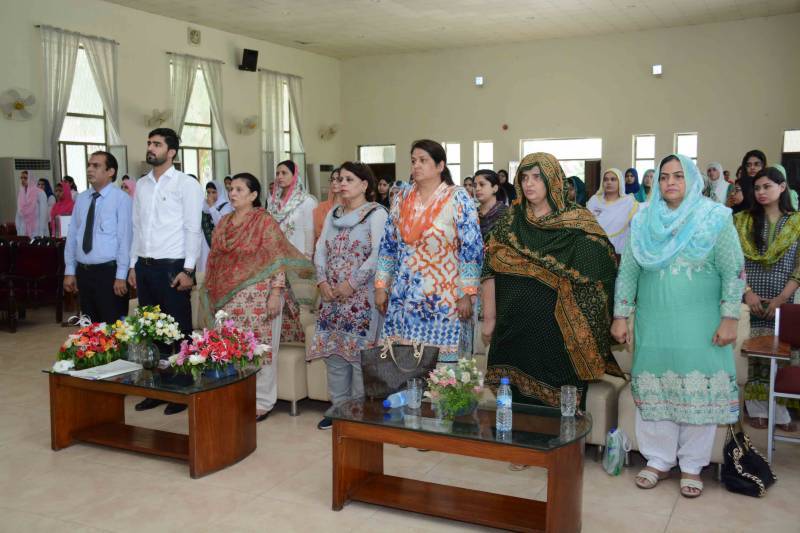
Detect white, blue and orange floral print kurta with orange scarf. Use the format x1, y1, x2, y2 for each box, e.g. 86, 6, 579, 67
375, 187, 483, 362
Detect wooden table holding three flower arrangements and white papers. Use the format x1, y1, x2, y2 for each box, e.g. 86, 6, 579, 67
49, 370, 256, 478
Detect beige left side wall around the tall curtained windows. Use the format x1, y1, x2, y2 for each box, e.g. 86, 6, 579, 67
0, 0, 341, 183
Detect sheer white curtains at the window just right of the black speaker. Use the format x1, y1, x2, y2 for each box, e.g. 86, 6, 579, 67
261, 71, 308, 190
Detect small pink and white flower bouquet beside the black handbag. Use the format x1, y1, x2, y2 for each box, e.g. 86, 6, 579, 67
424, 359, 483, 420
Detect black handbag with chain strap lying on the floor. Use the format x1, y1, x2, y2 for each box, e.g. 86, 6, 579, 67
722, 426, 778, 498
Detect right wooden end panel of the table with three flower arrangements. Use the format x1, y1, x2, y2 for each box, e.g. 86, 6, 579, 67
189, 374, 256, 478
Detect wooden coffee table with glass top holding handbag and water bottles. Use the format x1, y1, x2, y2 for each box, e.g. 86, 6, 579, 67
327, 400, 592, 533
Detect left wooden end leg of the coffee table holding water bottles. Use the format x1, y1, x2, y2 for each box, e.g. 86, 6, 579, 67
332, 420, 383, 511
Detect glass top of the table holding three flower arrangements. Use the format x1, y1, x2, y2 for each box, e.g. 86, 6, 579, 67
43, 367, 260, 394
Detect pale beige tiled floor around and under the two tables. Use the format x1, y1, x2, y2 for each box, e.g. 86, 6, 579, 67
0, 311, 800, 533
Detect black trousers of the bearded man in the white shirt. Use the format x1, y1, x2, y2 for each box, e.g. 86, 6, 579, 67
136, 258, 192, 337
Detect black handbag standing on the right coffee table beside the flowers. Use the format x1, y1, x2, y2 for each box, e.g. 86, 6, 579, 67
361, 342, 439, 400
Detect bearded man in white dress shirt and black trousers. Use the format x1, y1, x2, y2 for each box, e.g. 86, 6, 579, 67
128, 128, 203, 415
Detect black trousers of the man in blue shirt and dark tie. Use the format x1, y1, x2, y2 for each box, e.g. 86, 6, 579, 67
75, 261, 128, 324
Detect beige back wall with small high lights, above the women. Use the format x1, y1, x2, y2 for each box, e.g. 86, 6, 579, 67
342, 15, 800, 180
